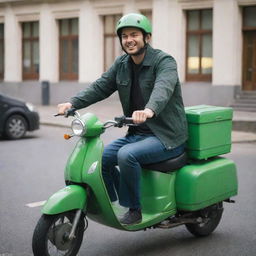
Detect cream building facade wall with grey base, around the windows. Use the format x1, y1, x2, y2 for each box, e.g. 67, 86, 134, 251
0, 0, 253, 105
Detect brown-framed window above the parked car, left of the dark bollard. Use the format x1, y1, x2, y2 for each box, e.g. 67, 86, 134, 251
22, 21, 39, 80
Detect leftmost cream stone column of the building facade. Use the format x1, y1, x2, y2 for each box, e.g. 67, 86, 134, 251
4, 6, 22, 82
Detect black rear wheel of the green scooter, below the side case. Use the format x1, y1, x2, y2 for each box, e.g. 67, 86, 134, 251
185, 202, 223, 237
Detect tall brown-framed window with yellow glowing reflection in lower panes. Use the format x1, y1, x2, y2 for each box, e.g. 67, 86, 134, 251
186, 9, 213, 81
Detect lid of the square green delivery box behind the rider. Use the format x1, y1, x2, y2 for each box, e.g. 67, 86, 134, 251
185, 105, 233, 123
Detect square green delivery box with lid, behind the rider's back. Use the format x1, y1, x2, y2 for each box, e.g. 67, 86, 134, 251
185, 105, 233, 159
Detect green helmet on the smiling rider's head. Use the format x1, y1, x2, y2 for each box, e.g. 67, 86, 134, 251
116, 13, 152, 37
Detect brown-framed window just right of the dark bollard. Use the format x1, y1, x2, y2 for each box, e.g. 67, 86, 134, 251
59, 18, 79, 80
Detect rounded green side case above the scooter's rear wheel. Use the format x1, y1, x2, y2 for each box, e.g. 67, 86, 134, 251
175, 157, 238, 211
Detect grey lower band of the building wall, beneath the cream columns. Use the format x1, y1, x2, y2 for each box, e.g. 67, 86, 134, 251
0, 82, 236, 106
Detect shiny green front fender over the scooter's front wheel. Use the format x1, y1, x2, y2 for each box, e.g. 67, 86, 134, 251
42, 185, 87, 215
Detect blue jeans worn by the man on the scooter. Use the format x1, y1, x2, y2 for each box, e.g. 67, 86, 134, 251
102, 135, 184, 208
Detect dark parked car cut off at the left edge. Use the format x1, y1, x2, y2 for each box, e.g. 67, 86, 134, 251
0, 94, 39, 139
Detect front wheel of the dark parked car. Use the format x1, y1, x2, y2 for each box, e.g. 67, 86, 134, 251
5, 115, 28, 140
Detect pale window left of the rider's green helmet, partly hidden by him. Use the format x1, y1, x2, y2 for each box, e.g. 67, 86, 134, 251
103, 14, 122, 70
